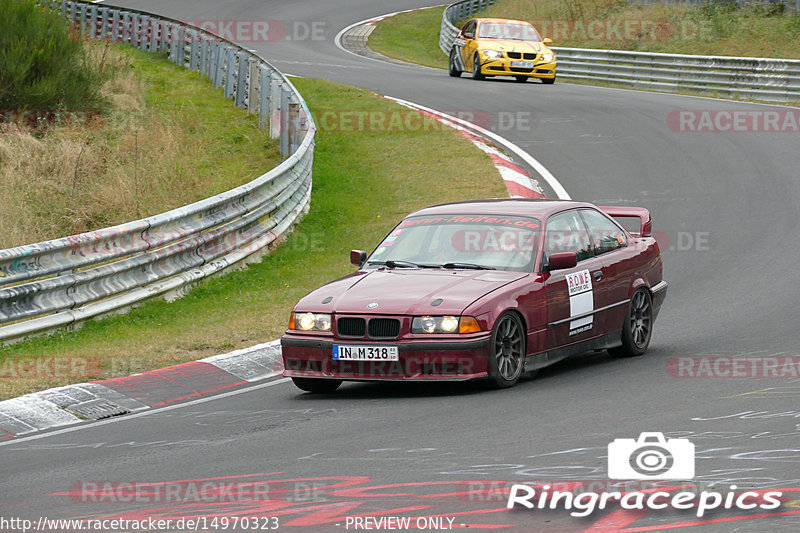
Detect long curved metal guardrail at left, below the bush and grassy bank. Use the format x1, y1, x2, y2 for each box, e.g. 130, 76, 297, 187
0, 1, 316, 342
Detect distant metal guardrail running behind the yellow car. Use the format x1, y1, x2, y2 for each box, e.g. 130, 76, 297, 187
439, 0, 800, 102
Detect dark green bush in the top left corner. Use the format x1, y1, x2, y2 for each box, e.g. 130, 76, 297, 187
0, 0, 106, 111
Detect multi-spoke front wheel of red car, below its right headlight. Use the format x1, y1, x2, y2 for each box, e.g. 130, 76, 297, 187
489, 312, 526, 389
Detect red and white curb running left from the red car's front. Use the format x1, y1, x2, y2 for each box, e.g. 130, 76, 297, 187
0, 340, 283, 440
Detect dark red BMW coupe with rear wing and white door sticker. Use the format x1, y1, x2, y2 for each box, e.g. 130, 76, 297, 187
281, 199, 667, 392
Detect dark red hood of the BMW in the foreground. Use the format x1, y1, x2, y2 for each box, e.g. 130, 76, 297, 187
295, 269, 526, 315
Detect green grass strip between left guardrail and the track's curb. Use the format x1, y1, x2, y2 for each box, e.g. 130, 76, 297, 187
0, 79, 507, 398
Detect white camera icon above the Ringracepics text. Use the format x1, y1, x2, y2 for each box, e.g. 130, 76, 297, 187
608, 433, 694, 480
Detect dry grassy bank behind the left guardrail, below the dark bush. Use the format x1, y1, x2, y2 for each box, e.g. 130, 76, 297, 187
0, 43, 280, 248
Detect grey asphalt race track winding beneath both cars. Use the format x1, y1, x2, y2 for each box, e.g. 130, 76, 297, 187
0, 0, 800, 532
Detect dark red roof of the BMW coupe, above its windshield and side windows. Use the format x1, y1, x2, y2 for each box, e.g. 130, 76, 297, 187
409, 198, 596, 220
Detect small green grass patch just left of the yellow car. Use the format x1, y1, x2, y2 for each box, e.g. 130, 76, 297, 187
369, 7, 447, 68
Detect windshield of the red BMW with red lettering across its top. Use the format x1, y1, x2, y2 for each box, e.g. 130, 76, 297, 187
366, 215, 541, 272
